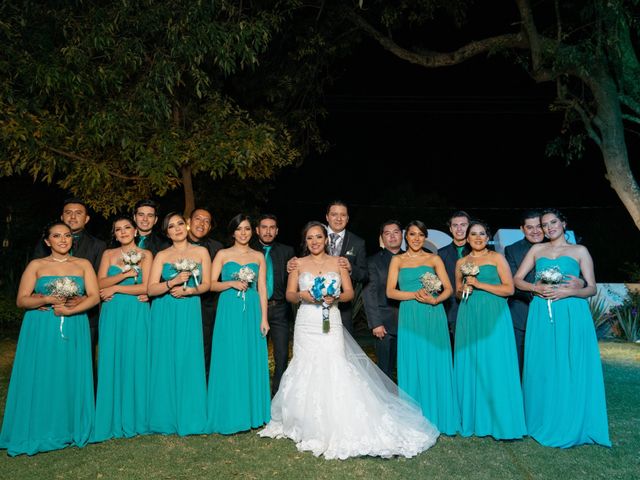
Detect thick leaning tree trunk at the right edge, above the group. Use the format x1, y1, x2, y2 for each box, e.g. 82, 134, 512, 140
582, 67, 640, 229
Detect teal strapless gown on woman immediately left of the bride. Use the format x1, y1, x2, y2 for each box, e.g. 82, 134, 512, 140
207, 262, 271, 434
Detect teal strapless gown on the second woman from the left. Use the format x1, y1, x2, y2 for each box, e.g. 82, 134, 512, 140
91, 265, 149, 442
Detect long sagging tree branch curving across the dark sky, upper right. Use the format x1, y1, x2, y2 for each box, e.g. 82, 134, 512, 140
344, 9, 529, 68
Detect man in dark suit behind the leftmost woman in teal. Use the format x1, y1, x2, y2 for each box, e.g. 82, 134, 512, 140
33, 198, 107, 376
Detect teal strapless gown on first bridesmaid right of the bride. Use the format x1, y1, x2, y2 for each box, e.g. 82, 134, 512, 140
398, 266, 460, 435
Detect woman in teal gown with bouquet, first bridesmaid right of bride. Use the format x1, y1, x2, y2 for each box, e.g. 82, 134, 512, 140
387, 220, 460, 435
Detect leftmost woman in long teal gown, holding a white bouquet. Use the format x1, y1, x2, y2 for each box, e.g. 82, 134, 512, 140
0, 222, 100, 456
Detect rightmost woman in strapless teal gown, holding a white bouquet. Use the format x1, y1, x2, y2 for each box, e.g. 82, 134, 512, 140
515, 209, 611, 448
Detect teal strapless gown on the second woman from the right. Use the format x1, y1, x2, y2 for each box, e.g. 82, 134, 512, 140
454, 265, 527, 439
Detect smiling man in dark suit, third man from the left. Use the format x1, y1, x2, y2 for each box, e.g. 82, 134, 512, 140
187, 207, 222, 381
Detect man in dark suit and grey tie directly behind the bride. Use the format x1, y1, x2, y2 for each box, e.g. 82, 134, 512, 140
326, 200, 368, 336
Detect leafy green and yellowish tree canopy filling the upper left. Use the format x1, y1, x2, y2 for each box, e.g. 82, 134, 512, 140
0, 0, 299, 213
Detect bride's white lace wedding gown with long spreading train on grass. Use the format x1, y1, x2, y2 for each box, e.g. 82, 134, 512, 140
259, 272, 439, 459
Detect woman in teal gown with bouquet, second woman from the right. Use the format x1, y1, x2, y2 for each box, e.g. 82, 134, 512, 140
454, 221, 526, 440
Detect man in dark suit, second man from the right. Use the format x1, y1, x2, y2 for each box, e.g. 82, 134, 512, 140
438, 210, 471, 351
